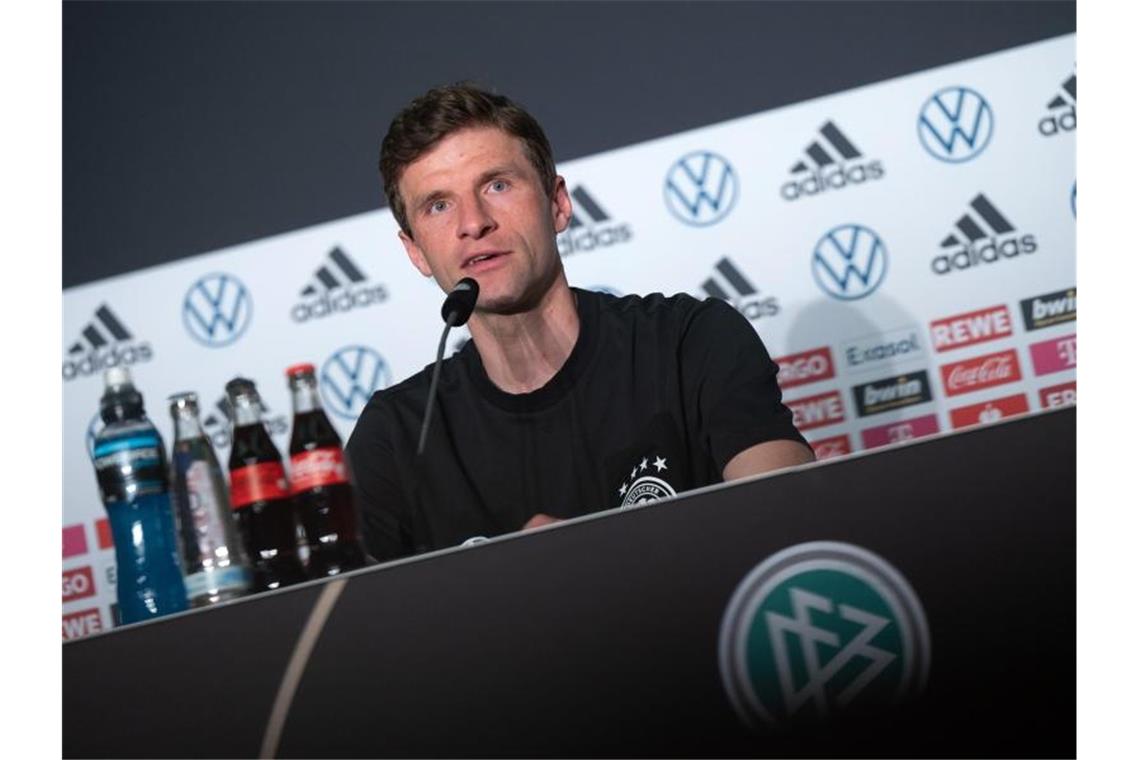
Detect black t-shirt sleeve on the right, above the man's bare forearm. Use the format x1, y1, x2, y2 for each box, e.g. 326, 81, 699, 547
681, 299, 807, 472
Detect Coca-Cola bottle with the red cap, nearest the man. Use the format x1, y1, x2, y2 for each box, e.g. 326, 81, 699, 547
285, 365, 375, 578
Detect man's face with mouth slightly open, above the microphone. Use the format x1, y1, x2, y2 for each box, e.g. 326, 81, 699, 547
399, 126, 570, 313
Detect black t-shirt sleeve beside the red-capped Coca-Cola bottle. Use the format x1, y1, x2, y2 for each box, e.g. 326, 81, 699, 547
344, 399, 413, 562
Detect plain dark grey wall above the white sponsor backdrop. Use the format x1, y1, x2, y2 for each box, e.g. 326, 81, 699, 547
63, 0, 1076, 287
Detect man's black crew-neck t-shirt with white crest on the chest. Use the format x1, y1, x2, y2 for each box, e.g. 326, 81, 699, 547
345, 288, 804, 559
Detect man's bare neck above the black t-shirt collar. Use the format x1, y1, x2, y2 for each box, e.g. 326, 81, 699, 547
469, 278, 580, 393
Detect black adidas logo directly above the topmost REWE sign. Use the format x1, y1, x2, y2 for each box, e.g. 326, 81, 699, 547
930, 193, 1037, 275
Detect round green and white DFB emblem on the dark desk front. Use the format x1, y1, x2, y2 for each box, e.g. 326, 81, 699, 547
718, 541, 930, 727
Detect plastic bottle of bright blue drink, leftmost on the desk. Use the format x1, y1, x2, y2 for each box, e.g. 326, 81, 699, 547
93, 367, 187, 623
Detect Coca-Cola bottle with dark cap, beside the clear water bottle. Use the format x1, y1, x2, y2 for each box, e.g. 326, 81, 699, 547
226, 377, 306, 591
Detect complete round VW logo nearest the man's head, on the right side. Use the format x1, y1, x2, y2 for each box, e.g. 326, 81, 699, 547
665, 150, 739, 227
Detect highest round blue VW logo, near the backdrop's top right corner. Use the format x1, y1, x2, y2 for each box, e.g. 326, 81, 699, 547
919, 87, 994, 163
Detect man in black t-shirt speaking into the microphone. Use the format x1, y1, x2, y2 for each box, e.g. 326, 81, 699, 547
347, 84, 814, 559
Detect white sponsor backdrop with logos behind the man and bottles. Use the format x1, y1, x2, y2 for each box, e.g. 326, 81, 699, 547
60, 35, 1076, 638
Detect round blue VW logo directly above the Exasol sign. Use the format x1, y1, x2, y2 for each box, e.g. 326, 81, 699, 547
812, 224, 887, 301
